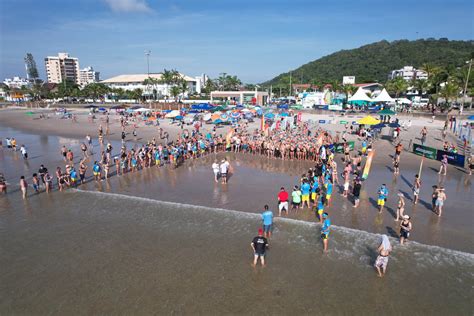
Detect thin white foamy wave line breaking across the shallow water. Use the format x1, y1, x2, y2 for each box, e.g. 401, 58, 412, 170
71, 189, 474, 265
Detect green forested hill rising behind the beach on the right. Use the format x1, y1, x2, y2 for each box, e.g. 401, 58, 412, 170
263, 39, 474, 85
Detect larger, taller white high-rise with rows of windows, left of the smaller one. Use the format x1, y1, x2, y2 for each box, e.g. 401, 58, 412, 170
44, 53, 81, 85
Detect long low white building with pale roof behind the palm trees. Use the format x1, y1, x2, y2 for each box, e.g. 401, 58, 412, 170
100, 74, 201, 97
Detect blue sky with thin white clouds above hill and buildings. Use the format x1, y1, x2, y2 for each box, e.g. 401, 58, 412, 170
0, 0, 474, 83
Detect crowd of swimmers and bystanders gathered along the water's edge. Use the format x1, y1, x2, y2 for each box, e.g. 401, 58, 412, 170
0, 111, 472, 276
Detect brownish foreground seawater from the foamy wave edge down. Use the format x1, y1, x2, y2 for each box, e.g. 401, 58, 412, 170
0, 190, 474, 315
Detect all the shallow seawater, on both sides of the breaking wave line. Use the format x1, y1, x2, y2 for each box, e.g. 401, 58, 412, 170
0, 124, 474, 315
